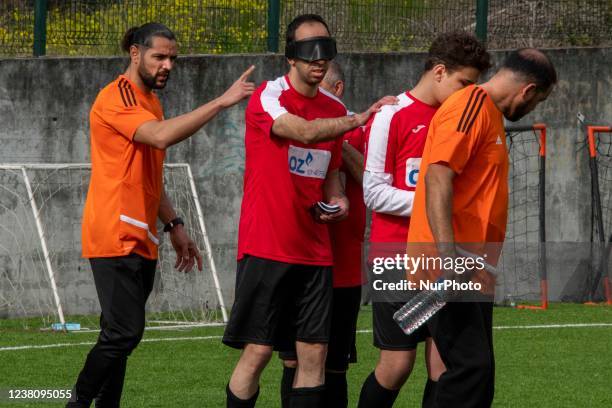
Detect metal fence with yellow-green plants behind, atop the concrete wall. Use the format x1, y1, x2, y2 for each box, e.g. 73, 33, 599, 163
0, 0, 612, 56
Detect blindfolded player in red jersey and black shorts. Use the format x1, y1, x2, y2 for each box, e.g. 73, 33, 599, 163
223, 14, 395, 408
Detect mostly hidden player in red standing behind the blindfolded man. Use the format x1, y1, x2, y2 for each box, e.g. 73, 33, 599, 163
279, 61, 366, 408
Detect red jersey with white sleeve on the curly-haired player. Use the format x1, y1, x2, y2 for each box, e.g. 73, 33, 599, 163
364, 92, 437, 245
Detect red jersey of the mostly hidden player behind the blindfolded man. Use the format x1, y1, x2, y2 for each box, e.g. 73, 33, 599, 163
329, 127, 366, 288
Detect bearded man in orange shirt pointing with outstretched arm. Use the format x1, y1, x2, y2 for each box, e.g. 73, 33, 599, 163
67, 23, 255, 408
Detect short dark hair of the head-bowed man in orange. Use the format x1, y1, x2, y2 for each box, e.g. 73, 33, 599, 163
501, 48, 557, 92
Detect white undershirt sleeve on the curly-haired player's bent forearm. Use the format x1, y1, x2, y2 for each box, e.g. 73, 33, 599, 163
363, 170, 414, 217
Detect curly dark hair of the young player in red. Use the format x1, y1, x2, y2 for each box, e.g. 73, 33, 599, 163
425, 31, 491, 72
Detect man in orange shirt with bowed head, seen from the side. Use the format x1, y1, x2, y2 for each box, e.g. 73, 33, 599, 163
408, 49, 557, 408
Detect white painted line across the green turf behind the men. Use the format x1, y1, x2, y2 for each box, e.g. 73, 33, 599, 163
0, 323, 612, 351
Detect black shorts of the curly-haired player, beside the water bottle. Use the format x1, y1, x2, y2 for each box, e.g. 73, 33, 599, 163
372, 302, 430, 350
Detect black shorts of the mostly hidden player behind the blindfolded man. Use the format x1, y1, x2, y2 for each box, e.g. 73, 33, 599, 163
278, 286, 361, 371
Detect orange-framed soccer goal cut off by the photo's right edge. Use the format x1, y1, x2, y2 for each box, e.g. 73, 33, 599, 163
587, 126, 612, 305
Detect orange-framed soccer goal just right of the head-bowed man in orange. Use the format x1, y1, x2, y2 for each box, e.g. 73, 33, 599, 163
498, 123, 548, 309
